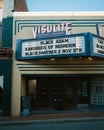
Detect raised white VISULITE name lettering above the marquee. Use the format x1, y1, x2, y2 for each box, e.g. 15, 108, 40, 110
33, 22, 72, 38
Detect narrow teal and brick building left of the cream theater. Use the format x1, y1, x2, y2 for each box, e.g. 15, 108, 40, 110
0, 0, 27, 115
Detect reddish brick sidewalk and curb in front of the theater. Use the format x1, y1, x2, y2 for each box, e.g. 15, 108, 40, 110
0, 108, 104, 126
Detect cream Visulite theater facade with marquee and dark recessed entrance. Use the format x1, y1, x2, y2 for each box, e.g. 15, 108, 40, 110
11, 12, 104, 115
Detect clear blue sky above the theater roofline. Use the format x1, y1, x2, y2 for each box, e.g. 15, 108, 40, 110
27, 0, 104, 12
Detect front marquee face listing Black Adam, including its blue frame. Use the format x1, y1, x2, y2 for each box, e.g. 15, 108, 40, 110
16, 34, 86, 60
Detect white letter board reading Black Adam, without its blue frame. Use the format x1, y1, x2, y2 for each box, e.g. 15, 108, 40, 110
21, 36, 85, 57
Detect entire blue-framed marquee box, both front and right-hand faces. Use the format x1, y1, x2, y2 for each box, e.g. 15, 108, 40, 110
16, 33, 104, 60
